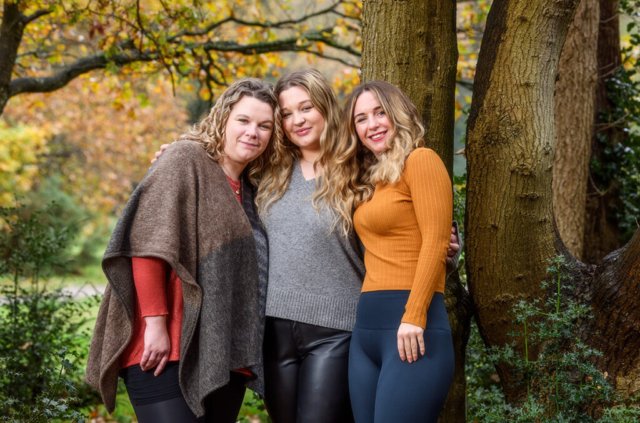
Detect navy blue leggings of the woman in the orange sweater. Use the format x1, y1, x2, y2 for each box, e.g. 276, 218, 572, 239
349, 291, 454, 423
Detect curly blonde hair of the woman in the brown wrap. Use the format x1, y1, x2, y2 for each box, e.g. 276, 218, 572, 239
178, 78, 282, 186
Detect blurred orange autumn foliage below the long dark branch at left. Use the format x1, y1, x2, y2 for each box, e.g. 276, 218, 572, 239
3, 73, 188, 216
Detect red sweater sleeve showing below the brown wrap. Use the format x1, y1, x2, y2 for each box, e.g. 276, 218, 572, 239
131, 257, 169, 317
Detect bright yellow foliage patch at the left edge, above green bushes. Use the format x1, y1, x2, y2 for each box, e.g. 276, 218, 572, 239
0, 121, 48, 207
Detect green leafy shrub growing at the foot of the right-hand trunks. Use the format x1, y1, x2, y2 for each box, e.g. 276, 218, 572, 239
467, 256, 640, 423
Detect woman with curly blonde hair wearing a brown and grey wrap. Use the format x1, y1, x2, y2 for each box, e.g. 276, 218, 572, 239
87, 79, 280, 423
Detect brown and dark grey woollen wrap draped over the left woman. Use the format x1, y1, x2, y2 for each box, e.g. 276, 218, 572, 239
86, 142, 267, 416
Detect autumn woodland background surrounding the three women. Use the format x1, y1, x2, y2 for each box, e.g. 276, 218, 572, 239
0, 0, 640, 421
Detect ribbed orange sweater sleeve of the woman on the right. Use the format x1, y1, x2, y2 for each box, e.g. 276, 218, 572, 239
402, 149, 453, 327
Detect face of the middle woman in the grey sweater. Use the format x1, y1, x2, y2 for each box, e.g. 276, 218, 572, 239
278, 87, 325, 151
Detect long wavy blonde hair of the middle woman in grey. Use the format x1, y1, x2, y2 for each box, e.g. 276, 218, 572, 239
256, 69, 340, 214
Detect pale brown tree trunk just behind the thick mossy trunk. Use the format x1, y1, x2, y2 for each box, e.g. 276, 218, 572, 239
553, 0, 600, 259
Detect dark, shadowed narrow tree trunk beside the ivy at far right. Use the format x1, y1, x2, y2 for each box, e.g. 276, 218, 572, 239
584, 0, 625, 263
